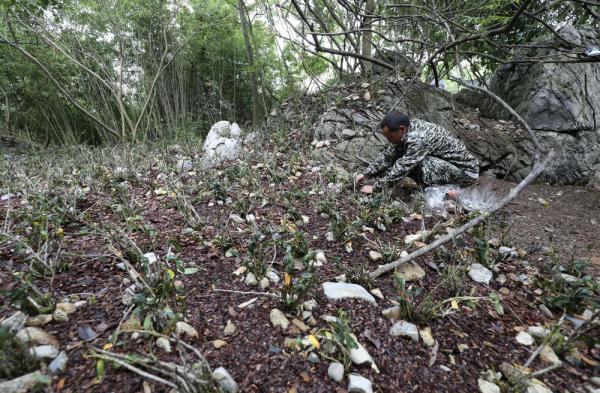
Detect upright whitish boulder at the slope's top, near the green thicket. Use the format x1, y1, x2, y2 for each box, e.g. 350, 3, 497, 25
203, 120, 242, 167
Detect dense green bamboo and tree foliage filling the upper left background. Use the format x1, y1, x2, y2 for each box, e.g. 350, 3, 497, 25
0, 0, 322, 143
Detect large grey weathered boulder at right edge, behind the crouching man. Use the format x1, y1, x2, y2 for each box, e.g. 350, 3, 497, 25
458, 26, 600, 184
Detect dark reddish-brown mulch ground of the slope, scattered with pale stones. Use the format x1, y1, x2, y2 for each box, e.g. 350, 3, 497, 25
0, 137, 600, 392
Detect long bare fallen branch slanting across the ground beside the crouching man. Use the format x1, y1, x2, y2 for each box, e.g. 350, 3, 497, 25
369, 151, 554, 278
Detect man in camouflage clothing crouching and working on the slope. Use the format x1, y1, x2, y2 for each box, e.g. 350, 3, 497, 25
356, 111, 479, 199
